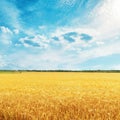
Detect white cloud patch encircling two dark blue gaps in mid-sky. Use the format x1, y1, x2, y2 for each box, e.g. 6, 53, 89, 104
51, 27, 98, 48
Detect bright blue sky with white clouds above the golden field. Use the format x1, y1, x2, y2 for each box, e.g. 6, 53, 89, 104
0, 0, 120, 70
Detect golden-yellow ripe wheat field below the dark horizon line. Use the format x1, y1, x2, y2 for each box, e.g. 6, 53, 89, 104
0, 72, 120, 120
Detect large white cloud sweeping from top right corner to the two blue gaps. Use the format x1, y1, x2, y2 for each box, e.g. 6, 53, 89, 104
51, 0, 120, 62
